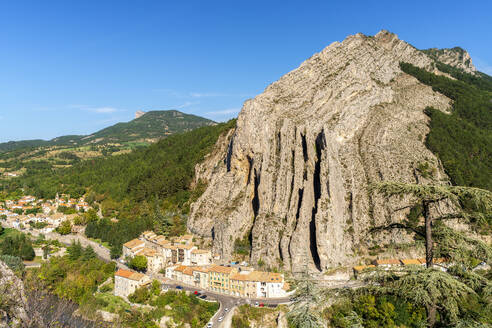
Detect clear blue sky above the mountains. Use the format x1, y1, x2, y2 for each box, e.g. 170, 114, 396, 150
0, 0, 492, 142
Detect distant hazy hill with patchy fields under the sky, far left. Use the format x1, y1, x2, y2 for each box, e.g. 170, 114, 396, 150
0, 110, 216, 183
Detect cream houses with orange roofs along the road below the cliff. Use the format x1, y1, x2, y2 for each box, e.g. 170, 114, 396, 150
114, 231, 289, 298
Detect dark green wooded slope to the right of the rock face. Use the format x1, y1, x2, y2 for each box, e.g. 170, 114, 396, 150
401, 62, 492, 190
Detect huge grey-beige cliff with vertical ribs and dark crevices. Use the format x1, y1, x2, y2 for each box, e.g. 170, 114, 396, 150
188, 31, 450, 273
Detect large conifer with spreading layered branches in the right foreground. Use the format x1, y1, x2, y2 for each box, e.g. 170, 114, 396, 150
368, 182, 492, 327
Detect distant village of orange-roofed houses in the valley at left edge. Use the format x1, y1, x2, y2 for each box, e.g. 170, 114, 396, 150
0, 195, 90, 233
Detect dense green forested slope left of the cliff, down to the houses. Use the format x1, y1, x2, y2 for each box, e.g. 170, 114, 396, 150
4, 120, 235, 256
